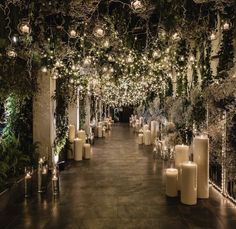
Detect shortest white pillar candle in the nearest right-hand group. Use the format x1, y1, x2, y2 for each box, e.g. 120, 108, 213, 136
166, 168, 178, 197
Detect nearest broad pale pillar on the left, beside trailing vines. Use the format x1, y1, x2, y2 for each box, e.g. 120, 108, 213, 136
33, 71, 56, 163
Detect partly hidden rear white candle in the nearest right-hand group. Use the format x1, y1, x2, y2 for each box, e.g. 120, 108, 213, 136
175, 145, 189, 190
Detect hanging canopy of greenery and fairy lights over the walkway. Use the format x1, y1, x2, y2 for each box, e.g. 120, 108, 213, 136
0, 0, 236, 197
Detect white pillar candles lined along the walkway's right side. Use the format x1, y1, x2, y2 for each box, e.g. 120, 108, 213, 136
130, 116, 209, 205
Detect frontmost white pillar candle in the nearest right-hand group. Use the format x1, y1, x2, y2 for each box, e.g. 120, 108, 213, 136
181, 161, 198, 205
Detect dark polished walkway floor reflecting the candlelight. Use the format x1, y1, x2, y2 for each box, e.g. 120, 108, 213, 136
0, 125, 236, 229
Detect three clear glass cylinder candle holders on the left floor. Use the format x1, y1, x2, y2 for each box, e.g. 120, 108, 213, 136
24, 158, 59, 198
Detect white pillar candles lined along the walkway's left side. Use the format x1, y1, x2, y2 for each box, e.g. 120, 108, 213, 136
68, 118, 113, 161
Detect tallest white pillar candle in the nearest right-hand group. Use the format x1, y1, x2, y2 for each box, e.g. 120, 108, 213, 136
193, 136, 209, 198
